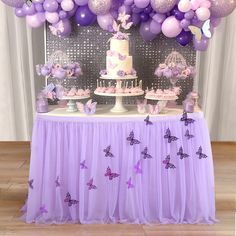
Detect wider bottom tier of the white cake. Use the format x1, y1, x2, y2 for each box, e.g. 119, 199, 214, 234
106, 56, 133, 76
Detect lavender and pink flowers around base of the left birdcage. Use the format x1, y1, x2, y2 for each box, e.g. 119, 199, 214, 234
36, 62, 83, 80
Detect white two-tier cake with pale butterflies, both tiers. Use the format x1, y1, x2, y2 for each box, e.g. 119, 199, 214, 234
106, 38, 133, 77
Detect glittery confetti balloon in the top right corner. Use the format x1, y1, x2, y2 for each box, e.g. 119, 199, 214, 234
210, 0, 236, 17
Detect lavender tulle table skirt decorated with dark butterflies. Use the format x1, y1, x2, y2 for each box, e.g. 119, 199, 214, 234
23, 112, 215, 224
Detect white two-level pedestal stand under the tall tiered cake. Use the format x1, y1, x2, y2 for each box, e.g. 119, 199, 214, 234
94, 75, 144, 113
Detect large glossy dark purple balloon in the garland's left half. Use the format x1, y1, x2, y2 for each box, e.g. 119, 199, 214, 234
75, 6, 96, 26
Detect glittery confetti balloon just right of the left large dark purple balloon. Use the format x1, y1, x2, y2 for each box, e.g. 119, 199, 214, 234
88, 0, 112, 15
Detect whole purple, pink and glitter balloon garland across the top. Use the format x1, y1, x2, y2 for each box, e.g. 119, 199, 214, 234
1, 0, 236, 51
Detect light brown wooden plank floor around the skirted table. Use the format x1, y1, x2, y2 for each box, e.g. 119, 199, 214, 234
0, 143, 236, 236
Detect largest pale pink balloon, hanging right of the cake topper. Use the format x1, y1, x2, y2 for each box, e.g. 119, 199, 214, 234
161, 16, 182, 38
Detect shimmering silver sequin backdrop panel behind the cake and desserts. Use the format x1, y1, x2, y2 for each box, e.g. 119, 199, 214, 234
46, 25, 196, 104
